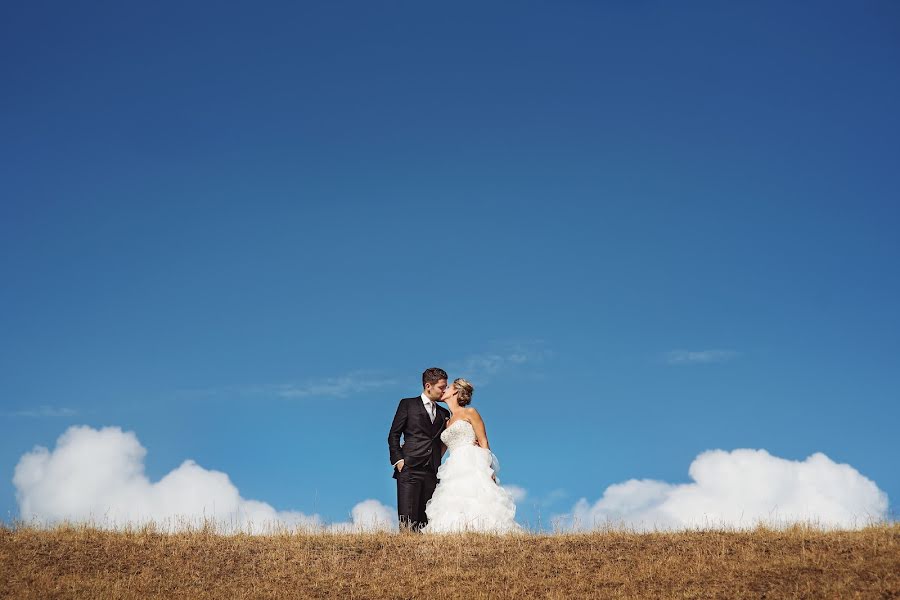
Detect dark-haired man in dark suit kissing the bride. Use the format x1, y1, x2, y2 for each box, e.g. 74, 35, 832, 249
388, 368, 450, 531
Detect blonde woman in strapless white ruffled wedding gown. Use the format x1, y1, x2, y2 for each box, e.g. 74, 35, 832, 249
422, 379, 523, 533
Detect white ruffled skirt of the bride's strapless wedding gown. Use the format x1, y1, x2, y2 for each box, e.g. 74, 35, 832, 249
423, 446, 523, 533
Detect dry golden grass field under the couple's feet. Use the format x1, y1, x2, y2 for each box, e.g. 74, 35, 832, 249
0, 524, 900, 600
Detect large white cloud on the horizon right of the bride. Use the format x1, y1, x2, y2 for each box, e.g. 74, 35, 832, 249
556, 449, 888, 530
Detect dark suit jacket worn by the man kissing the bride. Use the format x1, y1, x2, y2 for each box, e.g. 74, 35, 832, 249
388, 396, 450, 479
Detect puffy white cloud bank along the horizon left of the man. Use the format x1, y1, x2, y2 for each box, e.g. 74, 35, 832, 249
13, 426, 389, 533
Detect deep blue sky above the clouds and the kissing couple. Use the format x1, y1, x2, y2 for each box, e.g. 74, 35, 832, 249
0, 2, 900, 523
